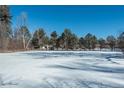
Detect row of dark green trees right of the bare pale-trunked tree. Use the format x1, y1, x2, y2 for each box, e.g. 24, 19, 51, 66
31, 28, 124, 51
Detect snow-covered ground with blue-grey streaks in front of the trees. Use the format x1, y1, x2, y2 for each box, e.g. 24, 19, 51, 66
0, 51, 124, 88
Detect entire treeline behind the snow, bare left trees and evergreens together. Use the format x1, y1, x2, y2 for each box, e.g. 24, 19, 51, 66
0, 5, 124, 52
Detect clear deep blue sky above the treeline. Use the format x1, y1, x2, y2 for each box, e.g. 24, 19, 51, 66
10, 5, 124, 38
